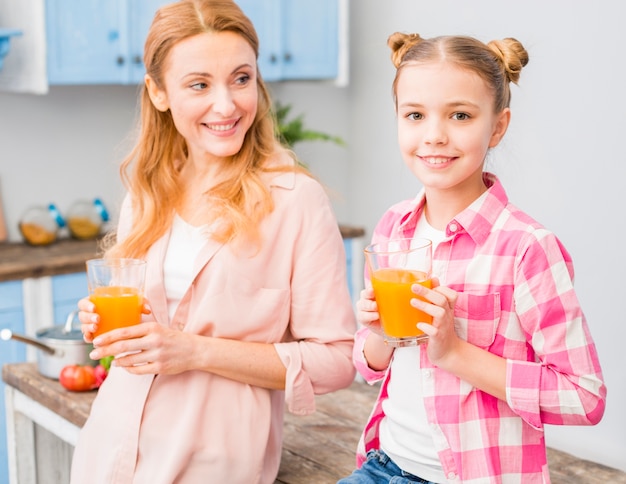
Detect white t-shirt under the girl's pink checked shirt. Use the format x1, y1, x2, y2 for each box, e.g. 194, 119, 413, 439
380, 212, 447, 483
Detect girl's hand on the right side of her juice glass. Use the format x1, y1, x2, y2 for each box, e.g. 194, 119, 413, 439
411, 278, 462, 366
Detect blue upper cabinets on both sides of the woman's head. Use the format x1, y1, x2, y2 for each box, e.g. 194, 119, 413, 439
46, 0, 339, 85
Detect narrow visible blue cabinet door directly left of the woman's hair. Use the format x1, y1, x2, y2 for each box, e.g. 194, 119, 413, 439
125, 0, 172, 84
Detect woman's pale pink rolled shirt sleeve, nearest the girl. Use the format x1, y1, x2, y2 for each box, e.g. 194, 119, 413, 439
274, 178, 356, 415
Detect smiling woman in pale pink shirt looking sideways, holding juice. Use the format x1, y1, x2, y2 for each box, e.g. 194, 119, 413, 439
71, 0, 356, 484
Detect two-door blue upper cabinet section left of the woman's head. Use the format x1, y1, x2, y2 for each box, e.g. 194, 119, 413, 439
46, 0, 171, 84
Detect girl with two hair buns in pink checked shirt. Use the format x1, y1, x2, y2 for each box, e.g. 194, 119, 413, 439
339, 33, 606, 484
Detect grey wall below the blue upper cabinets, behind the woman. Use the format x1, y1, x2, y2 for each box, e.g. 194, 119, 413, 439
0, 82, 349, 241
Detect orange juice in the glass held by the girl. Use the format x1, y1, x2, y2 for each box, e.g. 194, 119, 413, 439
371, 268, 432, 338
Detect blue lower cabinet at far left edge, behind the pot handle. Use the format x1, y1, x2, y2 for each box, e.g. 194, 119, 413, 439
0, 281, 26, 484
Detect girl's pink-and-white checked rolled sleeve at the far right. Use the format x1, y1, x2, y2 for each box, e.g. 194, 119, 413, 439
507, 229, 606, 428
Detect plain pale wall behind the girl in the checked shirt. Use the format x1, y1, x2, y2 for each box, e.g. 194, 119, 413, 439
347, 0, 626, 470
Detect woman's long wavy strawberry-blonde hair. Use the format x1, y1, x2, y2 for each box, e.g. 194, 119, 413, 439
104, 0, 302, 257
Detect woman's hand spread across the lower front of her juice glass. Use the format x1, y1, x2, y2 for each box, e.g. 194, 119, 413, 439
89, 321, 199, 375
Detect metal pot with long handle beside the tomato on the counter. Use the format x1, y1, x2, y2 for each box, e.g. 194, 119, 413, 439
0, 311, 98, 380
